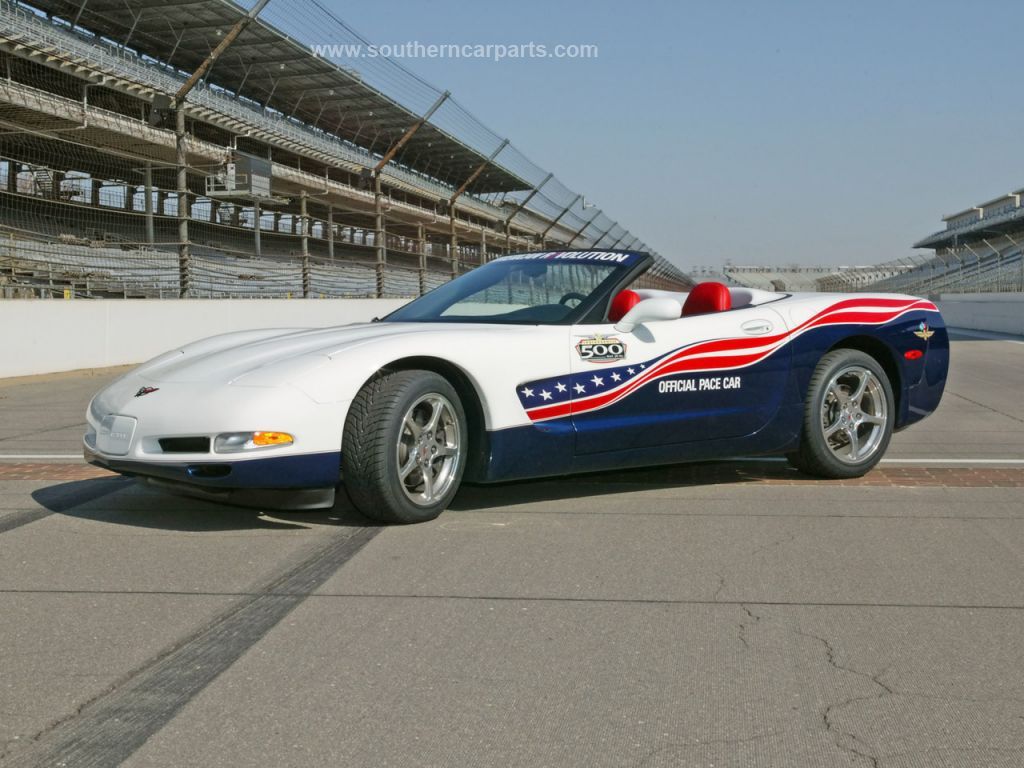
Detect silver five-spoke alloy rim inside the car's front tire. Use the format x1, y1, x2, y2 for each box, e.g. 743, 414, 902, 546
396, 392, 462, 507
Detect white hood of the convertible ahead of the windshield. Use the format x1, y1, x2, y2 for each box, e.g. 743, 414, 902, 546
136, 323, 497, 385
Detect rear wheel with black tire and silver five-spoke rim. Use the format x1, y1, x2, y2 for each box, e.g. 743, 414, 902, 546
786, 349, 896, 479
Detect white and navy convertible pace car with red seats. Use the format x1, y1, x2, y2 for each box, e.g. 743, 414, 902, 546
85, 251, 949, 522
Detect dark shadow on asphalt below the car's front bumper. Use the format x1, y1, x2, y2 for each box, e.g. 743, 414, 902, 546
32, 477, 379, 532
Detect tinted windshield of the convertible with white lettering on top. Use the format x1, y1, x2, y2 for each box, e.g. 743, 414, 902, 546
384, 251, 646, 325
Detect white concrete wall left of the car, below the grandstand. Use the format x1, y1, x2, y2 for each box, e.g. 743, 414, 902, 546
0, 299, 406, 378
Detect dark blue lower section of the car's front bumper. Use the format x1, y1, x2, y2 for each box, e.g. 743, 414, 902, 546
83, 443, 341, 510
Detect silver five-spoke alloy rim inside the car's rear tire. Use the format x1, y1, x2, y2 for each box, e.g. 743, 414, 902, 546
821, 366, 889, 464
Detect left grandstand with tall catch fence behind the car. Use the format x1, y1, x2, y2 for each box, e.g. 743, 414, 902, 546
0, 0, 689, 297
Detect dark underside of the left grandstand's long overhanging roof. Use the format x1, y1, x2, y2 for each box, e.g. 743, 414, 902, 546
31, 0, 532, 195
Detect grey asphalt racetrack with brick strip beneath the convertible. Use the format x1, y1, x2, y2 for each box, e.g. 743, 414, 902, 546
0, 335, 1024, 768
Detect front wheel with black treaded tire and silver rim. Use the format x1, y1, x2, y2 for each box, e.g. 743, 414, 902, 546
341, 371, 469, 523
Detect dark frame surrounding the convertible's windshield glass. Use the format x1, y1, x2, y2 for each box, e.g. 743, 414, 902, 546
380, 249, 654, 326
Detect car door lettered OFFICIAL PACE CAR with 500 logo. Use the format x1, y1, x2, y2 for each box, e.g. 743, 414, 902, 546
567, 306, 790, 454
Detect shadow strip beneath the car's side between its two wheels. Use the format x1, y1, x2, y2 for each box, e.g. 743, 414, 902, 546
449, 460, 798, 512
